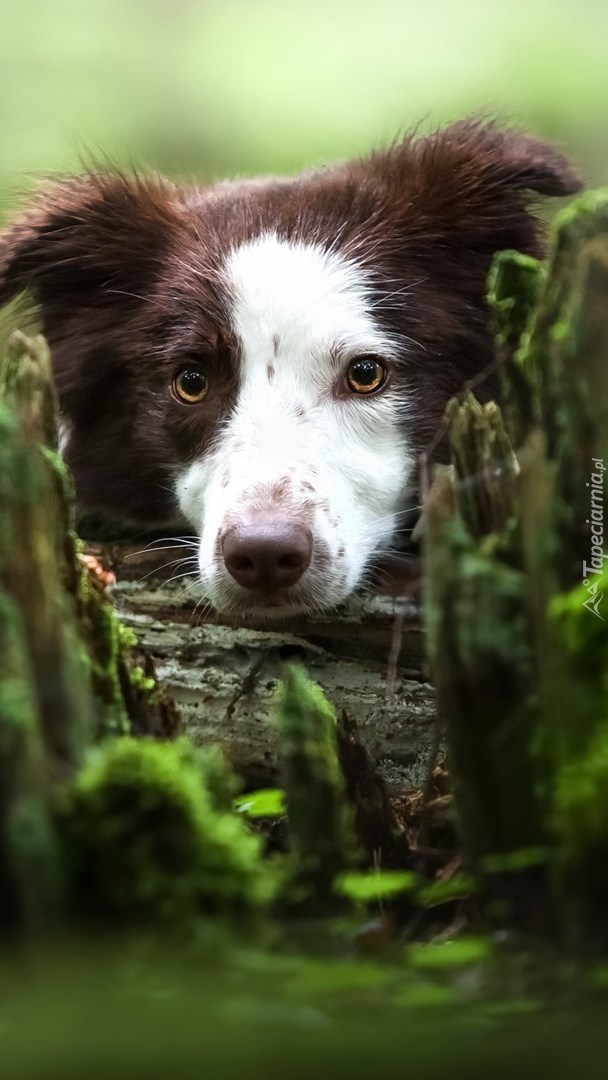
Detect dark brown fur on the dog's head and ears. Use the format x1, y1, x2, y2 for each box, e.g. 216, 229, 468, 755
0, 120, 580, 522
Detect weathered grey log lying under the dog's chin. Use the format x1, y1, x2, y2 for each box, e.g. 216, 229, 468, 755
87, 544, 435, 792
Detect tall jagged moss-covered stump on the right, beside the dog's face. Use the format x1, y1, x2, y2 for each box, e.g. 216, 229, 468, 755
425, 193, 608, 930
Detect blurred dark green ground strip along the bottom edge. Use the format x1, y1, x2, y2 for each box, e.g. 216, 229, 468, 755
0, 939, 608, 1080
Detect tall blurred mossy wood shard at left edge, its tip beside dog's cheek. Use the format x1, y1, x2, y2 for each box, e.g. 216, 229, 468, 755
0, 335, 93, 765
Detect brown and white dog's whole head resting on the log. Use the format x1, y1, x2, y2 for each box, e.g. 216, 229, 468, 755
0, 121, 579, 617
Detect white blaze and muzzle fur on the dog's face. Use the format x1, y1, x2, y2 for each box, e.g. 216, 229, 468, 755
178, 233, 413, 616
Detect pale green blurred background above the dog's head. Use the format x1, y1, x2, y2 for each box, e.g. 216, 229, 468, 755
0, 0, 608, 210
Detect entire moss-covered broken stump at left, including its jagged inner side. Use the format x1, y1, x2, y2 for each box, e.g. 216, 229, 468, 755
0, 334, 180, 930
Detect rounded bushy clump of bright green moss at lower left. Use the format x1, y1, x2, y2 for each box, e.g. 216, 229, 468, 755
58, 738, 272, 927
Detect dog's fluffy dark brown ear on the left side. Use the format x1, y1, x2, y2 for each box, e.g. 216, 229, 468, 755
0, 172, 183, 328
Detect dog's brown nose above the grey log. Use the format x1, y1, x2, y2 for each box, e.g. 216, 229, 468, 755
221, 516, 312, 593
